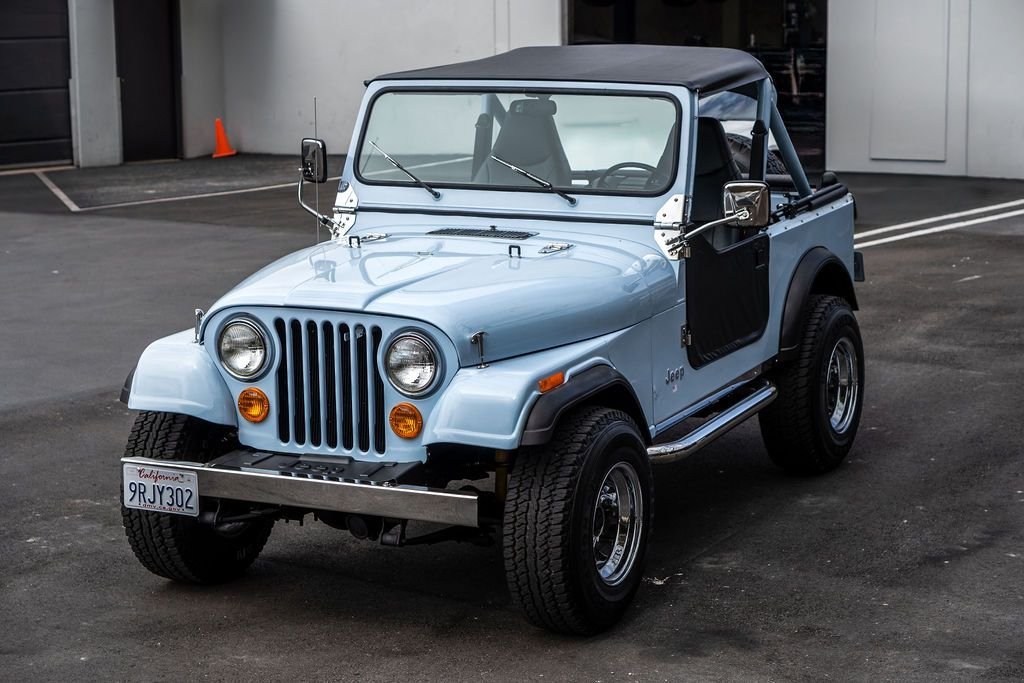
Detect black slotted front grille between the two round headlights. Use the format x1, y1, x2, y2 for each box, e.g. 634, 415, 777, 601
273, 317, 385, 455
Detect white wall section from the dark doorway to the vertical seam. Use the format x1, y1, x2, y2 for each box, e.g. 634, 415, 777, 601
825, 0, 971, 175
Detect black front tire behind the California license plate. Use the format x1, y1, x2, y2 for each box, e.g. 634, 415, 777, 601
121, 413, 273, 584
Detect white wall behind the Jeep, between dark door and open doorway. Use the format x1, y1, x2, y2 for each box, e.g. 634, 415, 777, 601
181, 0, 565, 156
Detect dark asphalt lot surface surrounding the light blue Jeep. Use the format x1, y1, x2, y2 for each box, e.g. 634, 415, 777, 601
0, 166, 1024, 681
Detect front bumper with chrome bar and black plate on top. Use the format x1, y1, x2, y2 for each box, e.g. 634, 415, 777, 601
121, 451, 479, 526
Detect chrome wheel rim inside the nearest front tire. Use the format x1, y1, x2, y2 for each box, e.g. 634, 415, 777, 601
593, 463, 643, 586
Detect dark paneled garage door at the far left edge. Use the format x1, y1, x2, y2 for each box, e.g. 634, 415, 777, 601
0, 0, 72, 166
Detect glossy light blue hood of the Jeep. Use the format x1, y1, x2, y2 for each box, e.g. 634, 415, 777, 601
204, 226, 676, 366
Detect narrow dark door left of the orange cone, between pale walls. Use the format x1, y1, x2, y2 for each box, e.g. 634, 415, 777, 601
114, 0, 180, 161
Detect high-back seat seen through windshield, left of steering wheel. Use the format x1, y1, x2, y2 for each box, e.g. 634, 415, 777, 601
473, 98, 572, 187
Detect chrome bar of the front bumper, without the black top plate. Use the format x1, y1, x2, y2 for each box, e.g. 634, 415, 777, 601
121, 458, 479, 526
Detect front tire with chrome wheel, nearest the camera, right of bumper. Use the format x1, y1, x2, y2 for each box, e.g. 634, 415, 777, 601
503, 408, 653, 635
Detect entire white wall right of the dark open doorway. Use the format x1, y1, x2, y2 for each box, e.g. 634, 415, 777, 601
825, 0, 1024, 178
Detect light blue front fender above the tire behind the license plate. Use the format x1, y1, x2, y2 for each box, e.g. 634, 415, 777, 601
127, 330, 238, 427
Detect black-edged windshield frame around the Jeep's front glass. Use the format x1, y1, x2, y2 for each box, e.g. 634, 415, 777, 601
351, 83, 683, 199
